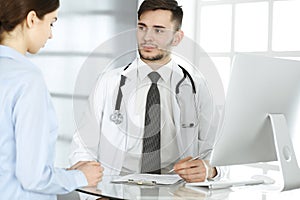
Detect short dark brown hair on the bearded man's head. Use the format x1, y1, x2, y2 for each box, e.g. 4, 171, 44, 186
138, 0, 183, 30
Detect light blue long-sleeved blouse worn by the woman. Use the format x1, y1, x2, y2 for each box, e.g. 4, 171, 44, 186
0, 45, 87, 200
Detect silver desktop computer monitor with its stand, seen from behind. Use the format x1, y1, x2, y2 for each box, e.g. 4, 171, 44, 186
210, 54, 300, 190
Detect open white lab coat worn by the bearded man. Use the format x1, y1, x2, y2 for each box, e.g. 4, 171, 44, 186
70, 60, 224, 175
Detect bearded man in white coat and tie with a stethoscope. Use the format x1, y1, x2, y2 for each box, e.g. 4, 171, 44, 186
70, 0, 221, 182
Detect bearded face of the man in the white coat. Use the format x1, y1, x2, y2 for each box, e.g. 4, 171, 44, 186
137, 10, 183, 64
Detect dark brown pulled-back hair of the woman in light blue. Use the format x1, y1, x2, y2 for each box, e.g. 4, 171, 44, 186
0, 0, 59, 41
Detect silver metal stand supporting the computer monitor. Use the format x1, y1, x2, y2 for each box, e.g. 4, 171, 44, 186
268, 114, 300, 191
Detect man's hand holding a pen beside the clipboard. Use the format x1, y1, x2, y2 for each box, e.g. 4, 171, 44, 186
174, 157, 217, 183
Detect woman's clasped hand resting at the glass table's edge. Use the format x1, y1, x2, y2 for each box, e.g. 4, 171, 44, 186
69, 161, 104, 186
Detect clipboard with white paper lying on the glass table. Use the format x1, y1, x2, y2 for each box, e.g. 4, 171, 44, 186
112, 174, 182, 185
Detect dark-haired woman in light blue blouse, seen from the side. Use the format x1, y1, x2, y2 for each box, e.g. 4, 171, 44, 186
0, 0, 103, 200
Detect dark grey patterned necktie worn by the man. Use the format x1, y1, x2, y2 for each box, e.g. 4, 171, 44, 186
141, 72, 161, 174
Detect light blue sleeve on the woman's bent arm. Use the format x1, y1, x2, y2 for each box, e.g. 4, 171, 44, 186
13, 72, 87, 194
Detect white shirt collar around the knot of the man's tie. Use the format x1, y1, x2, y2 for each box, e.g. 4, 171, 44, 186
137, 59, 173, 82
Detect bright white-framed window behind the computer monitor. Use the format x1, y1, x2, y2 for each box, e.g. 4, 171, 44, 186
195, 0, 300, 90
